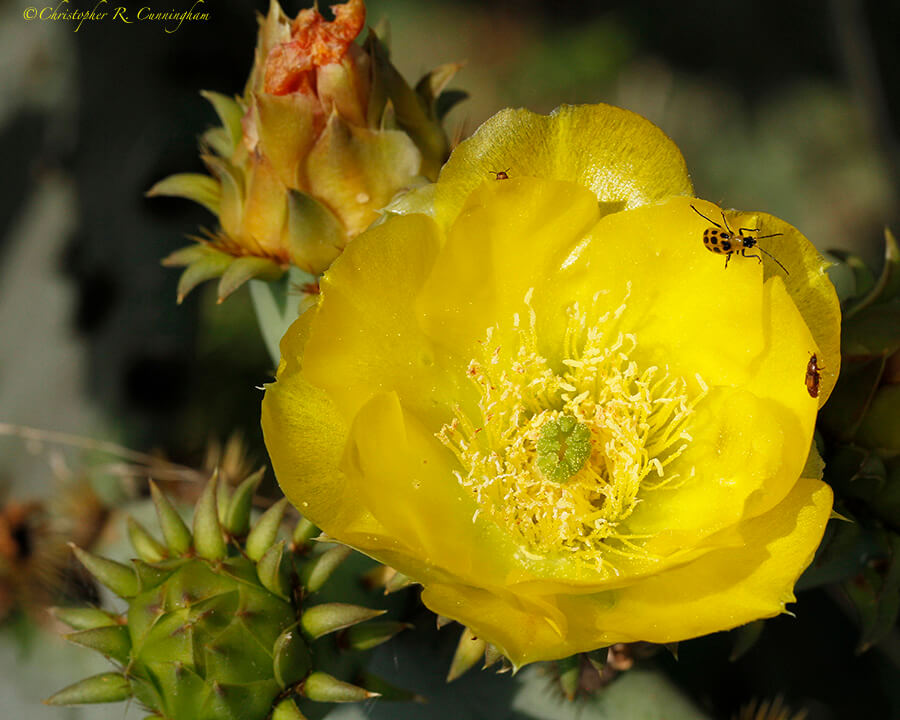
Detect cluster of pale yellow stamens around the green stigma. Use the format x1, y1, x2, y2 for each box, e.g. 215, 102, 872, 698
437, 290, 706, 575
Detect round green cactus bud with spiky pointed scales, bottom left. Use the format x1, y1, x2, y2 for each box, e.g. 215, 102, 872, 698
47, 472, 406, 720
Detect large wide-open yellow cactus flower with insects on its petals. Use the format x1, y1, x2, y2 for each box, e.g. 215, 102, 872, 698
262, 105, 840, 666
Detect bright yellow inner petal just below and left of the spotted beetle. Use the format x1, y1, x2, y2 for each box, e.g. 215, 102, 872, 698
534, 198, 765, 386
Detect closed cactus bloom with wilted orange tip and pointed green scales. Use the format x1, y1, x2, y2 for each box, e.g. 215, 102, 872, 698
148, 0, 464, 301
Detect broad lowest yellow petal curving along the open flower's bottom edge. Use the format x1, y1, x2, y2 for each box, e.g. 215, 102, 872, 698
422, 480, 832, 665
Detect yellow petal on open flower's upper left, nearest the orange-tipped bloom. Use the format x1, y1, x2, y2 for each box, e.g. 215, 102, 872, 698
304, 215, 464, 427
